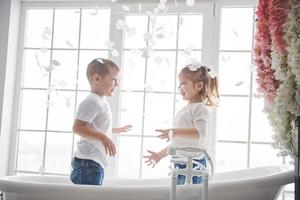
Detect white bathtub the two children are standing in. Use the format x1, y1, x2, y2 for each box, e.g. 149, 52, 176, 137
0, 166, 294, 200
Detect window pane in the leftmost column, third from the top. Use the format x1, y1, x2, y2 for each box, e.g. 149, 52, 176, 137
20, 90, 47, 130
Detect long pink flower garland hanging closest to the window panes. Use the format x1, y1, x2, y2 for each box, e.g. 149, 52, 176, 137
254, 0, 280, 103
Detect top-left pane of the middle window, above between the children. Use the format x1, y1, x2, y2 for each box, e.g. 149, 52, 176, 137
125, 15, 148, 49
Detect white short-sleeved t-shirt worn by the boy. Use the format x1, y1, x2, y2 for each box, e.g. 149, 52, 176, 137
74, 93, 112, 167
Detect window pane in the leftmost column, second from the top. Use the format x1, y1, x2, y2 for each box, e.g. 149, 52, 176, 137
23, 50, 50, 88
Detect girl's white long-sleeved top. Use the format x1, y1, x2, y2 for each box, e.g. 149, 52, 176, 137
170, 102, 210, 154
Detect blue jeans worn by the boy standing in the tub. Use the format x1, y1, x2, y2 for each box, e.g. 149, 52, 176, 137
70, 157, 104, 185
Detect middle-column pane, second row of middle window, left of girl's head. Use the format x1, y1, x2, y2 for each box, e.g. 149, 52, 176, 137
146, 51, 175, 92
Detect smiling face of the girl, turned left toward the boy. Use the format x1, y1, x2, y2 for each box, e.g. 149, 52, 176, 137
178, 73, 203, 102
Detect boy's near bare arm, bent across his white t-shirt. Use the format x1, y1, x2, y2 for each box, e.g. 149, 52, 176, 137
73, 119, 116, 156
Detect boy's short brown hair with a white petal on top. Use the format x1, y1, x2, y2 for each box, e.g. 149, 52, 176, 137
86, 58, 120, 82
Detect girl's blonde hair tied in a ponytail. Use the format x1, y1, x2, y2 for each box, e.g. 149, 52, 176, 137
179, 64, 219, 106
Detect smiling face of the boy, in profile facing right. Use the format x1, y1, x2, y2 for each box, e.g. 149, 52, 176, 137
93, 67, 119, 96
